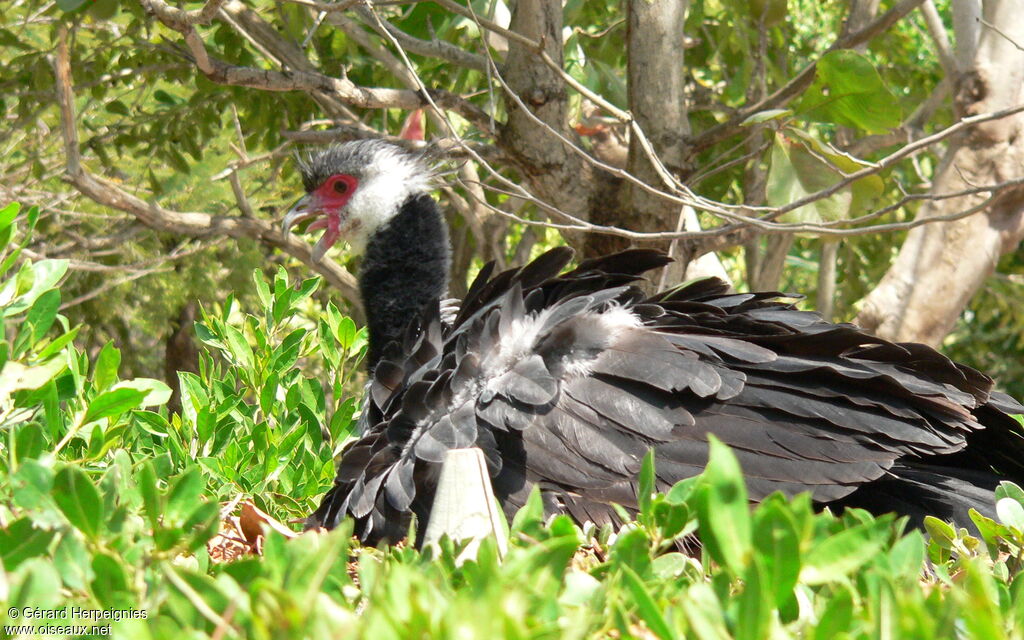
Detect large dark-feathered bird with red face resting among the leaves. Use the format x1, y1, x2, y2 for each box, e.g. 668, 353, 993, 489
283, 139, 1024, 545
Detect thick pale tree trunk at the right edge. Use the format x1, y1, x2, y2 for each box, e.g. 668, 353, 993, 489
857, 0, 1024, 345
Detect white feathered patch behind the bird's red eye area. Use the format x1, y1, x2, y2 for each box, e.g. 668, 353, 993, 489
343, 147, 432, 253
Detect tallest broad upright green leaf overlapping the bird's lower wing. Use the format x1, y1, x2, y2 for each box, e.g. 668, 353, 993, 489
694, 434, 752, 573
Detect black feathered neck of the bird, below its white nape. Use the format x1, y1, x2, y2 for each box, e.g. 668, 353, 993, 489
359, 194, 451, 373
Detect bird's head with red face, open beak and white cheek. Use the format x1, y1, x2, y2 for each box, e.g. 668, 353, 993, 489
283, 140, 433, 261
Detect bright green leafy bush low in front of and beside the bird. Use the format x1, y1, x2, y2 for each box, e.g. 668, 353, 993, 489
0, 200, 1024, 640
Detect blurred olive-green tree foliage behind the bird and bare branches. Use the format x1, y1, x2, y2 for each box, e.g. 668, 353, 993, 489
0, 0, 1024, 395
